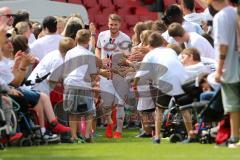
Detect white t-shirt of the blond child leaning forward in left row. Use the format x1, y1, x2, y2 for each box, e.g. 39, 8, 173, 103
28, 50, 64, 94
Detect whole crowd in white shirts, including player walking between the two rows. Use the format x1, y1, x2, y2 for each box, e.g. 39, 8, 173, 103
0, 0, 240, 148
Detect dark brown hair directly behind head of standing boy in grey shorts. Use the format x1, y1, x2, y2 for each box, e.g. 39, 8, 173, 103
64, 21, 82, 39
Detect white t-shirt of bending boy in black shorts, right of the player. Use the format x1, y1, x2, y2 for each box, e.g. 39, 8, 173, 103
135, 47, 188, 96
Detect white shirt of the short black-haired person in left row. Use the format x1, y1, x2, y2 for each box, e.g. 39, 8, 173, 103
30, 34, 62, 60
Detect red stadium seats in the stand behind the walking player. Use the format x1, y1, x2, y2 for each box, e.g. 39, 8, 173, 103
52, 0, 158, 36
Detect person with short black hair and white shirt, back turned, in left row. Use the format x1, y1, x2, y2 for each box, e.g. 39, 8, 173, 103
30, 16, 62, 60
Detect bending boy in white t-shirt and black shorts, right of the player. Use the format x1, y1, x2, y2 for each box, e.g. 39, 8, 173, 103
134, 32, 191, 143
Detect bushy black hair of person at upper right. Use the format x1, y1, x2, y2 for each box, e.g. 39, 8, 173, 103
162, 4, 183, 26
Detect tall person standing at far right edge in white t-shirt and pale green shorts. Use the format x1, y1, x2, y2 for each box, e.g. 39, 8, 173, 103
208, 0, 240, 148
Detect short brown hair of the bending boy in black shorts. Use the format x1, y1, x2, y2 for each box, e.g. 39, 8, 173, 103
148, 31, 163, 48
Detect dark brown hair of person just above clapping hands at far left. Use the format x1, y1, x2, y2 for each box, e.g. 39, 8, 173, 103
12, 35, 29, 55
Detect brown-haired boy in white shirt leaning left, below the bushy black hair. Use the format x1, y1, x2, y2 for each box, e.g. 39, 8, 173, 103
168, 23, 215, 59
